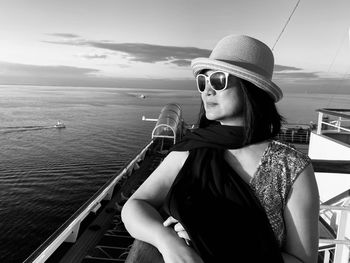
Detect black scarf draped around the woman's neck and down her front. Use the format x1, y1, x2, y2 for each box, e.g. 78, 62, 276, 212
166, 125, 283, 263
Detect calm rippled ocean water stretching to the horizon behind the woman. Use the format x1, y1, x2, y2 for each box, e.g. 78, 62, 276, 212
0, 85, 350, 262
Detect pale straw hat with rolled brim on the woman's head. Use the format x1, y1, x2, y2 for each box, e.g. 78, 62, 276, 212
191, 35, 283, 102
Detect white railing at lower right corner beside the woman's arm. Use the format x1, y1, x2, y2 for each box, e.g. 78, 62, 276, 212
319, 195, 350, 263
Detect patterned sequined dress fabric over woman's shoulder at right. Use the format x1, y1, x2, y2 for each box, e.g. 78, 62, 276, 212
250, 140, 311, 247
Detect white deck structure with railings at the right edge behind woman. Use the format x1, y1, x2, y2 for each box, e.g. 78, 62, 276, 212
308, 109, 350, 263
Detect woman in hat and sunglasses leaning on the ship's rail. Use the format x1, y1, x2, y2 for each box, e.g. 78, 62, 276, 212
122, 35, 319, 263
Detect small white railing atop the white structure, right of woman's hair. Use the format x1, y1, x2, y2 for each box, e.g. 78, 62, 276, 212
317, 108, 350, 134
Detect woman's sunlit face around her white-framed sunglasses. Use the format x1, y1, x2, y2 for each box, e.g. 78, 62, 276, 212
201, 70, 243, 126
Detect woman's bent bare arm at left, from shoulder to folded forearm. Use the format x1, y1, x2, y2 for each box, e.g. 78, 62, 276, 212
121, 152, 202, 262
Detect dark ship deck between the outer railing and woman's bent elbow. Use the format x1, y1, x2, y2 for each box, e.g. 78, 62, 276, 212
47, 139, 170, 263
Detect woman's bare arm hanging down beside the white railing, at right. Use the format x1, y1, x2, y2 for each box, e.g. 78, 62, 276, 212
283, 165, 319, 263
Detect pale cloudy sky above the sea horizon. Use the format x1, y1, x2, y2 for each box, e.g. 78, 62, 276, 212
0, 0, 350, 93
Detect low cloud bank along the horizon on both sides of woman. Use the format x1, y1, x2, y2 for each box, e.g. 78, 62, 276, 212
0, 61, 350, 94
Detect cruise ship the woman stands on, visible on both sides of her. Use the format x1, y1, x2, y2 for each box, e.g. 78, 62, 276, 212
25, 104, 350, 263
